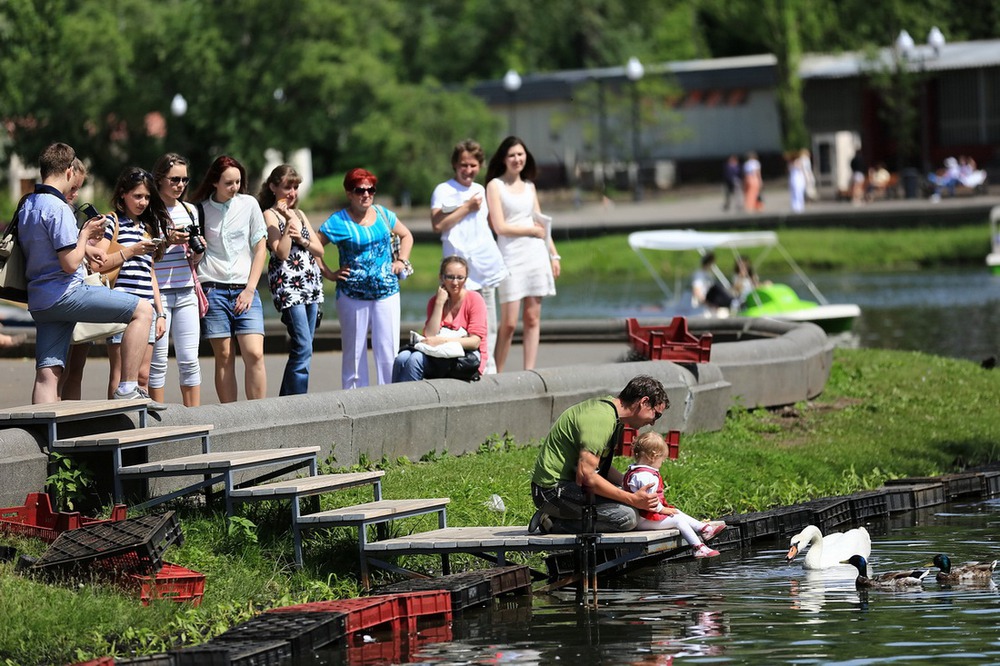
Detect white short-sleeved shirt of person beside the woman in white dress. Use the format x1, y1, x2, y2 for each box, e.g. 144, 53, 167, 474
431, 178, 507, 291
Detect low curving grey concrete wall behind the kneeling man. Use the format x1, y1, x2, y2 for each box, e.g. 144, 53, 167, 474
0, 320, 833, 506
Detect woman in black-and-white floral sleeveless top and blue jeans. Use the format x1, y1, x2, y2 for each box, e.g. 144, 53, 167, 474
257, 164, 323, 395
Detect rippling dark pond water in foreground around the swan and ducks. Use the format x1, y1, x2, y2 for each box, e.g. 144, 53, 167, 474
318, 500, 1000, 666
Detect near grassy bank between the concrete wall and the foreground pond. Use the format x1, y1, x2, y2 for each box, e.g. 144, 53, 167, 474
0, 350, 1000, 664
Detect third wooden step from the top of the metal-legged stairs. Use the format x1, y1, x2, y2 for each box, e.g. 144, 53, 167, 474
119, 446, 320, 516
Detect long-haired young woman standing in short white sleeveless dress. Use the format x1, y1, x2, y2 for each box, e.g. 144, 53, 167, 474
486, 136, 560, 372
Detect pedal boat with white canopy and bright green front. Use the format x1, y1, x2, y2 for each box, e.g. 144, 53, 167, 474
628, 230, 861, 333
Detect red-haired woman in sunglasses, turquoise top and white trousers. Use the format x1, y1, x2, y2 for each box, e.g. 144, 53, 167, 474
319, 169, 413, 389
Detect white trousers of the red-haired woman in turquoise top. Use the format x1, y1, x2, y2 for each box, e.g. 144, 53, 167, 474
337, 292, 400, 389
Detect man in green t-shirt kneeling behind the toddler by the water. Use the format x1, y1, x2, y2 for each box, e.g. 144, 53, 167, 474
528, 375, 670, 534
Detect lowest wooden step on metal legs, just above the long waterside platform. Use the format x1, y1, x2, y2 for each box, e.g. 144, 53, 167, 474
295, 497, 451, 590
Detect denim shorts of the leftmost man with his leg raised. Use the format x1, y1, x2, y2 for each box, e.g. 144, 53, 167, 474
31, 284, 139, 368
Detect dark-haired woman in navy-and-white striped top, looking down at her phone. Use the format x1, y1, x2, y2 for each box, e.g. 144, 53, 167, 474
100, 167, 170, 398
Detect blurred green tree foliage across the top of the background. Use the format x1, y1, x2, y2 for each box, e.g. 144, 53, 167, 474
0, 0, 1000, 199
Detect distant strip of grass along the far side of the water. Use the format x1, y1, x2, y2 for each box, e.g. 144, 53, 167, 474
382, 221, 990, 291
